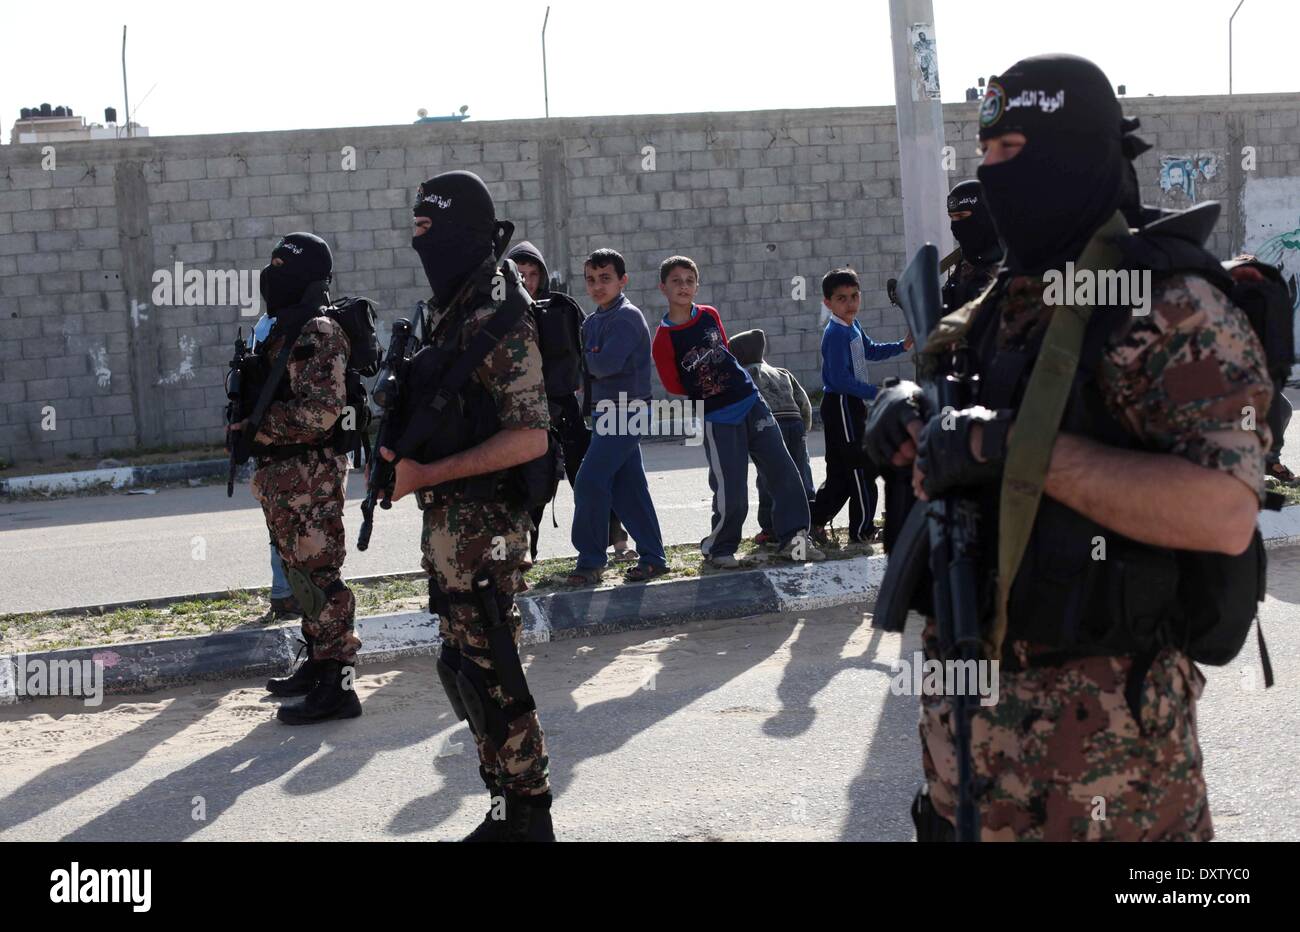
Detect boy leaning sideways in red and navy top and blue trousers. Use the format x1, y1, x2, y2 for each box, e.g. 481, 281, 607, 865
654, 256, 826, 569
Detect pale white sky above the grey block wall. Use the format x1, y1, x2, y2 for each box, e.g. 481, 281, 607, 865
0, 0, 1300, 143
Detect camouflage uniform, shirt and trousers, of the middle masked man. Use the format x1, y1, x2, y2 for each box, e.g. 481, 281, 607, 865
420, 295, 550, 796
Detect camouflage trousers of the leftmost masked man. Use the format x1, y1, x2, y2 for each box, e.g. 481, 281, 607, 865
252, 451, 361, 663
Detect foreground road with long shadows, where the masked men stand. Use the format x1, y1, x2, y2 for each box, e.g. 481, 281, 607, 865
0, 550, 1300, 841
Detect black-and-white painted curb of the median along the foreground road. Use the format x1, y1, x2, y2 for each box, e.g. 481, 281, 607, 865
0, 506, 1300, 703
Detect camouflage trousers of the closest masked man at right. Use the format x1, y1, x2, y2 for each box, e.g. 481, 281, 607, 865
920, 623, 1214, 841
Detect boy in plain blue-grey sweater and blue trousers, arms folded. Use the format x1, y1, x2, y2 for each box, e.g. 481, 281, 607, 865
566, 250, 668, 585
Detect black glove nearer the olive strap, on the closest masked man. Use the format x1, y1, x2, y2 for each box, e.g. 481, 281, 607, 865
917, 407, 1013, 499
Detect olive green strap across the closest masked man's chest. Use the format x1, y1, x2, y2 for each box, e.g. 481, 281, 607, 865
985, 211, 1128, 659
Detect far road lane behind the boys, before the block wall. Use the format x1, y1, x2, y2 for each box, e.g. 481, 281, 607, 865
0, 432, 848, 614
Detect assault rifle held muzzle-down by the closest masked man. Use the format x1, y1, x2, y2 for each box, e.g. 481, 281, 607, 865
875, 243, 980, 841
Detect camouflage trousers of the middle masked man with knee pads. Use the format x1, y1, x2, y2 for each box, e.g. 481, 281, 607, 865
420, 500, 550, 796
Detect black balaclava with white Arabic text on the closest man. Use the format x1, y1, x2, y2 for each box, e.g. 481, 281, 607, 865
975, 55, 1149, 274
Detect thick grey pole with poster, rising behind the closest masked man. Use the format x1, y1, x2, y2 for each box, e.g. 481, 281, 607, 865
889, 0, 952, 263
